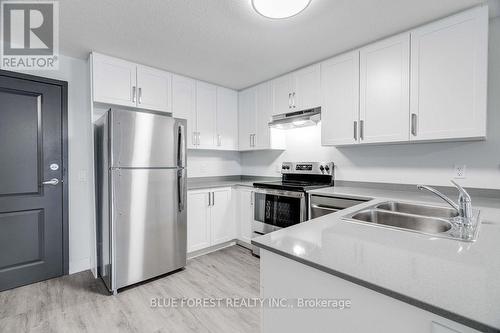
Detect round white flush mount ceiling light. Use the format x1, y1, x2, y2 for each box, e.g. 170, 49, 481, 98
252, 0, 311, 19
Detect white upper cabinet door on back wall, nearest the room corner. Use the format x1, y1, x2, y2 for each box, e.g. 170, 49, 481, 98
215, 87, 238, 150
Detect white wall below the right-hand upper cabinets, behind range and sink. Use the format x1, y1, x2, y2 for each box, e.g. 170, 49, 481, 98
241, 17, 500, 189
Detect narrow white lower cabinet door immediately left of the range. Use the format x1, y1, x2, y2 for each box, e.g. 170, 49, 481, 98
235, 187, 254, 244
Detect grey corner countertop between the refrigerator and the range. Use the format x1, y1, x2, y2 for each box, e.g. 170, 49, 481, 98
187, 175, 281, 190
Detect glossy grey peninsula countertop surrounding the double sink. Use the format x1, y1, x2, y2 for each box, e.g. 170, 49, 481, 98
252, 186, 500, 332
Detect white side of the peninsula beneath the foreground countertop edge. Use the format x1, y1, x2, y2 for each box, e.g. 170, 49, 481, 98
260, 249, 479, 333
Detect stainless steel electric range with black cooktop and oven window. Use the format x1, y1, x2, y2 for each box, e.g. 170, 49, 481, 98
252, 162, 334, 255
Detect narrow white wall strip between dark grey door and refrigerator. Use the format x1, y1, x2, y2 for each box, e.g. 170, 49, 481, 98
14, 56, 93, 273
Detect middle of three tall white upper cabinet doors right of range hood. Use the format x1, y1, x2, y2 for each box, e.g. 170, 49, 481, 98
360, 33, 410, 143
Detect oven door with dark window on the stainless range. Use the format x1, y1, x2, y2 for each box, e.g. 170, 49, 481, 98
254, 188, 307, 233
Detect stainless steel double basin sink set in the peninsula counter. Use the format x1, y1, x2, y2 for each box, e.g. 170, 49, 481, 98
343, 201, 479, 241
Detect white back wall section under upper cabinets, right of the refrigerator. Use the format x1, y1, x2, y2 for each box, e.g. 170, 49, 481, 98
187, 150, 241, 177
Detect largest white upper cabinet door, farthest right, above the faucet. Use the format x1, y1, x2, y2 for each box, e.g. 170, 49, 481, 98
410, 6, 488, 141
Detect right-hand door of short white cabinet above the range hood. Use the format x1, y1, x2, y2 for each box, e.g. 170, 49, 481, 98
292, 64, 321, 111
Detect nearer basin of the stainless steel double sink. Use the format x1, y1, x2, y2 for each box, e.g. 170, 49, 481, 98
352, 209, 451, 234
